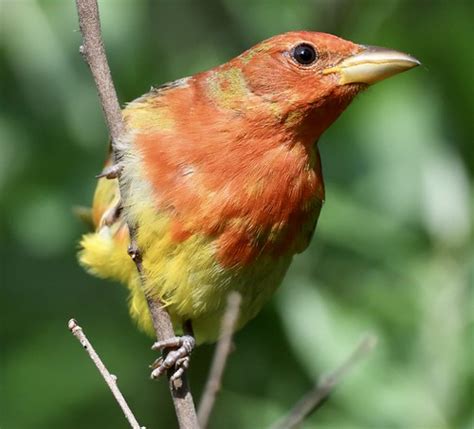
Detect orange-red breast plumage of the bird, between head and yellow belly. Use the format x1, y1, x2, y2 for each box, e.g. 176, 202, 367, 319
130, 91, 324, 267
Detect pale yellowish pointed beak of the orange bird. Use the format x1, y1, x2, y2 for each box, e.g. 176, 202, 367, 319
323, 46, 421, 85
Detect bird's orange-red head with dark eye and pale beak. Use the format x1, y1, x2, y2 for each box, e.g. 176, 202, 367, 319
209, 31, 420, 139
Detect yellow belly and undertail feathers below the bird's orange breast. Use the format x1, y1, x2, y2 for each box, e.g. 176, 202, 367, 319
80, 205, 292, 343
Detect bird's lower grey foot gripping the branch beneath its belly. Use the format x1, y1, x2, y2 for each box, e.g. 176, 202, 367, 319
151, 335, 196, 381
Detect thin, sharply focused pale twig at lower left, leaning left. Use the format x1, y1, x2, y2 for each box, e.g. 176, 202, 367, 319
68, 319, 145, 429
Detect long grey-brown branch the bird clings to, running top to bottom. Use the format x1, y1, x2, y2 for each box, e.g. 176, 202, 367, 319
75, 0, 198, 429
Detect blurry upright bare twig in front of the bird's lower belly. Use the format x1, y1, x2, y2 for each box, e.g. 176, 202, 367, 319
198, 292, 242, 429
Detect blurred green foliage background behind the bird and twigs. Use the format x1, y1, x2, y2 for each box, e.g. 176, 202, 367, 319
0, 0, 474, 429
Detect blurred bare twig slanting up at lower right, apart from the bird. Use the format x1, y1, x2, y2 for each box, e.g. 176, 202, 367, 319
271, 335, 377, 429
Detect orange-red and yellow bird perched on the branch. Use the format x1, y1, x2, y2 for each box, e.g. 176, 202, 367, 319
78, 31, 420, 377
